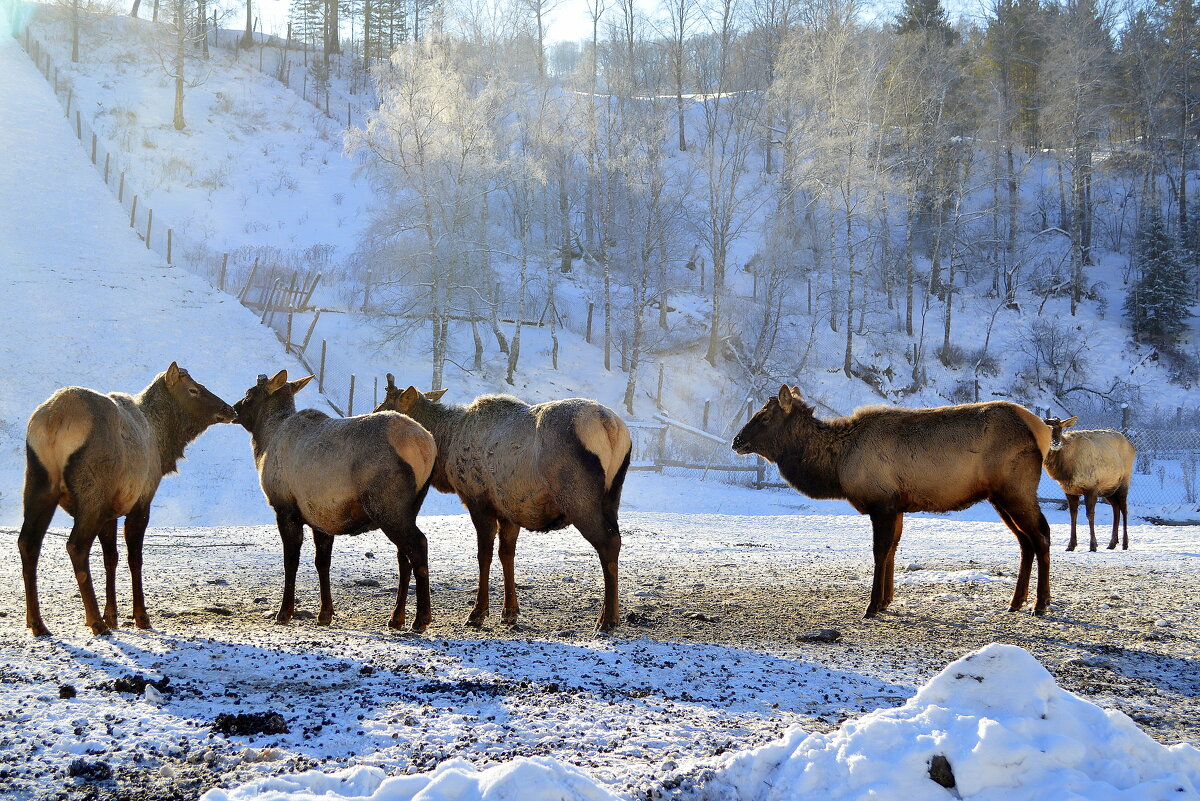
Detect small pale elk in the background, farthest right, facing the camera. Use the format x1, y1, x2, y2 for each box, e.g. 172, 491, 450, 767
1045, 417, 1136, 550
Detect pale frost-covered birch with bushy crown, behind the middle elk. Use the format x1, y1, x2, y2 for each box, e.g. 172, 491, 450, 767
348, 43, 506, 387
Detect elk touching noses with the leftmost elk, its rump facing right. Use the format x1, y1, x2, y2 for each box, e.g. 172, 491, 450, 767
234, 371, 436, 632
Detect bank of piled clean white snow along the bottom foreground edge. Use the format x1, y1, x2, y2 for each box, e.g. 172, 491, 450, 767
202, 643, 1200, 801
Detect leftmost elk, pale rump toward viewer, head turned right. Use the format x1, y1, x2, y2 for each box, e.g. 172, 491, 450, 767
17, 362, 234, 637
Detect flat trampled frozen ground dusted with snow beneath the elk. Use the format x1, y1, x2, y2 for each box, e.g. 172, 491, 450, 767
0, 501, 1200, 799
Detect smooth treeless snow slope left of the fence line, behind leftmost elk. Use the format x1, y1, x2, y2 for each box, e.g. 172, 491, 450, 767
0, 17, 316, 525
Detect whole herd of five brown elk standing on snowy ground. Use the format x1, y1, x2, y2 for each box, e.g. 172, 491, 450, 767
18, 363, 1134, 637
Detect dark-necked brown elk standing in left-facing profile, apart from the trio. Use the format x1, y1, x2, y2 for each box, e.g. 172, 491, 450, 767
733, 386, 1050, 618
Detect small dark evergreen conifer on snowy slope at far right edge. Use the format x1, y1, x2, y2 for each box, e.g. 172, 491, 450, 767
1124, 213, 1193, 350
